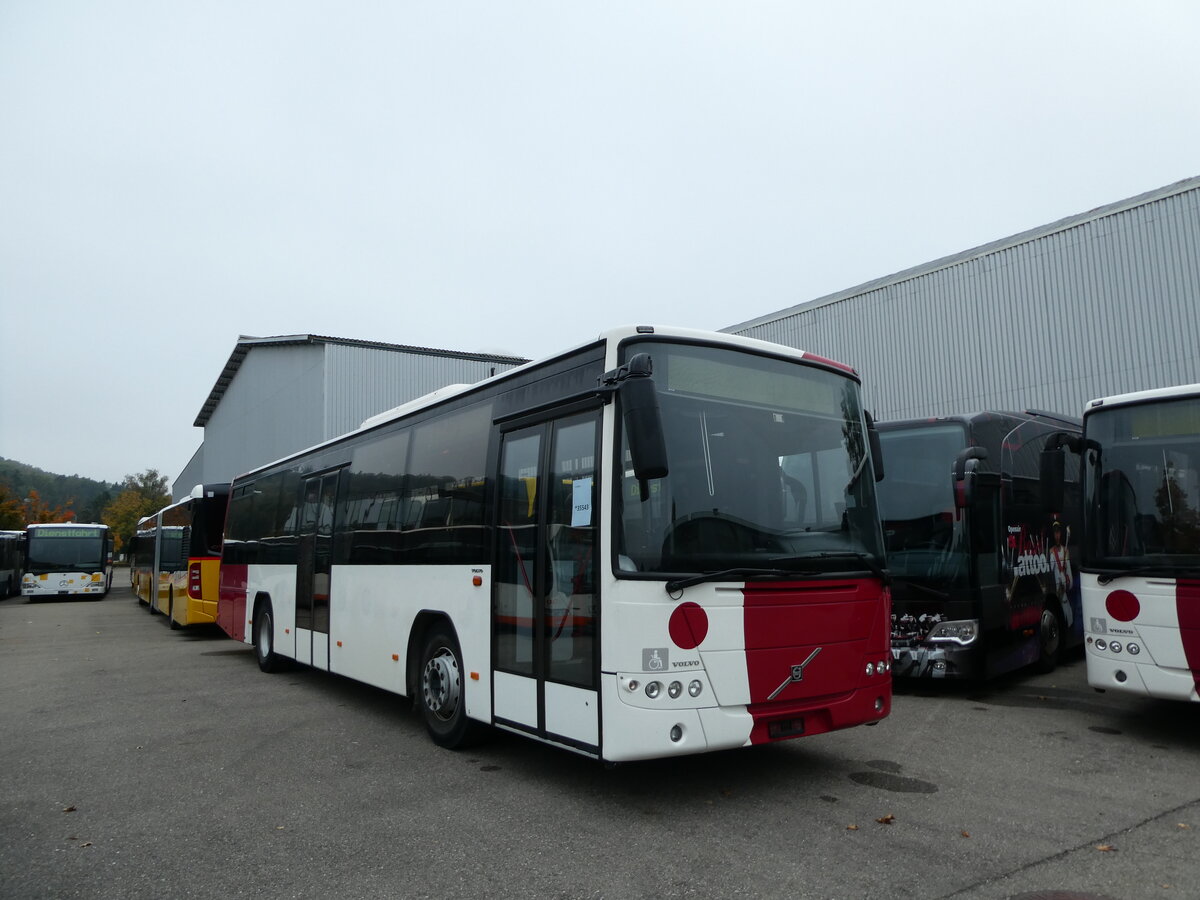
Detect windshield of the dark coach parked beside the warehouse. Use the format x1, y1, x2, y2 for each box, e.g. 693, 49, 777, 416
876, 422, 968, 586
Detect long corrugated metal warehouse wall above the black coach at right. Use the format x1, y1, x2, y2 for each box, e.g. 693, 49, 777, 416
724, 178, 1200, 420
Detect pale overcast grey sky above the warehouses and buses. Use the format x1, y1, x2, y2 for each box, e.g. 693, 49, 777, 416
0, 0, 1200, 480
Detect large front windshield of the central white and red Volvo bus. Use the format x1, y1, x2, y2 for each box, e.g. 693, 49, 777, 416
618, 342, 883, 574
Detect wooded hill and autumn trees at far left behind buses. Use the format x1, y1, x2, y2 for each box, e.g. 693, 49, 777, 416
0, 458, 170, 552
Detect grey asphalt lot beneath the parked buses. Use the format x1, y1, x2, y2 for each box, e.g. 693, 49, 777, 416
0, 580, 1200, 900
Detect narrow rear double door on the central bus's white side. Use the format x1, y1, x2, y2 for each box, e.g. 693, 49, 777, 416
296, 472, 338, 668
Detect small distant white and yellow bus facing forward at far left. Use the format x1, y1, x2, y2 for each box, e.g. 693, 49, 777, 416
20, 522, 113, 601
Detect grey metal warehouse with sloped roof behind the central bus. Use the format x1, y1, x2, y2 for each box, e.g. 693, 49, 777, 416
173, 335, 528, 499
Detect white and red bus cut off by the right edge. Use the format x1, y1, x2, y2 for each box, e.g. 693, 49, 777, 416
1046, 384, 1200, 702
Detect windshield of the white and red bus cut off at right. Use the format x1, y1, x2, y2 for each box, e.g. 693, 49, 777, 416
1084, 397, 1200, 572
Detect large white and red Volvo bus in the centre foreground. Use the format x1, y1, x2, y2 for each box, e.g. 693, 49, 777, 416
218, 326, 892, 762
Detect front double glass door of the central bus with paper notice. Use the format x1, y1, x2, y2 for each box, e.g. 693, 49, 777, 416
492, 412, 600, 750
